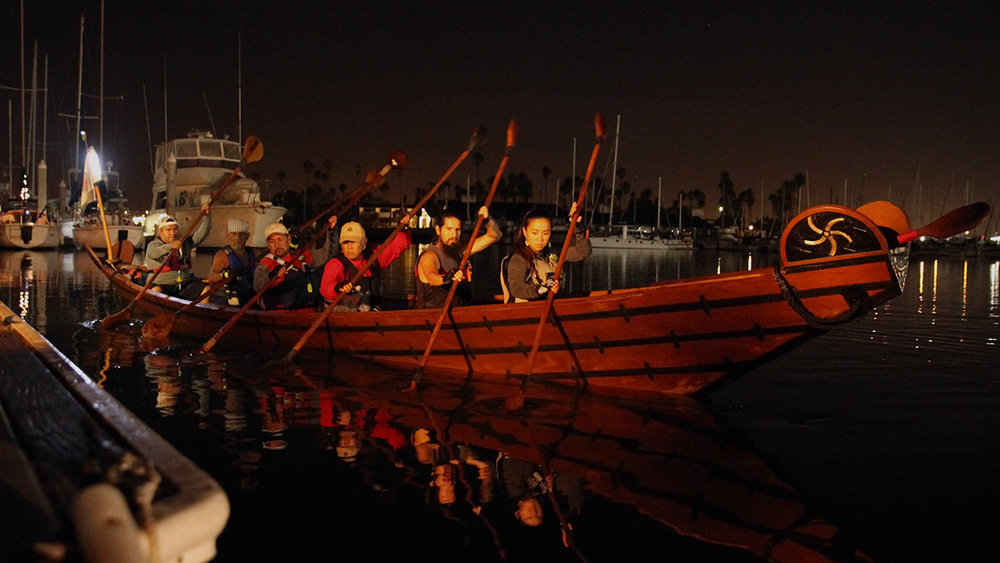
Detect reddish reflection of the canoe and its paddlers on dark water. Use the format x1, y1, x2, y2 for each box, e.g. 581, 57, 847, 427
127, 347, 868, 561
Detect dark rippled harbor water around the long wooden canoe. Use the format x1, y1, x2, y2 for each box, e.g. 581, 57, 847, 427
0, 251, 1000, 562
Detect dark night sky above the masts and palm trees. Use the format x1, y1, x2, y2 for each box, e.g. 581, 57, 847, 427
0, 0, 1000, 227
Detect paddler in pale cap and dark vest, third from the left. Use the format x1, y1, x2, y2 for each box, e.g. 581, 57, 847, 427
253, 215, 337, 309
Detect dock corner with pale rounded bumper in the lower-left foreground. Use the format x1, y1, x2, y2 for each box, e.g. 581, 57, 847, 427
0, 303, 229, 562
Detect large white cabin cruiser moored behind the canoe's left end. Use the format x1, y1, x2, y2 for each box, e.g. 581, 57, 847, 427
143, 132, 285, 248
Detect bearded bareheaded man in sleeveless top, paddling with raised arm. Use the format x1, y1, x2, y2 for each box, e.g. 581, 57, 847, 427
416, 206, 503, 309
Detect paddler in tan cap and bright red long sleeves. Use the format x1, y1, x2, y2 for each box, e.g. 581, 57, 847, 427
320, 221, 413, 311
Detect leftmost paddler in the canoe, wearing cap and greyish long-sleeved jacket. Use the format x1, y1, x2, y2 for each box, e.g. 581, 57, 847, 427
143, 215, 205, 300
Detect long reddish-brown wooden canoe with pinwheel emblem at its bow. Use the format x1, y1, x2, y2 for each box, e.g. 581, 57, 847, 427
92, 203, 909, 394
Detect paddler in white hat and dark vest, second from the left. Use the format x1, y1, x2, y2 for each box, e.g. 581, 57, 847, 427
206, 219, 257, 307
